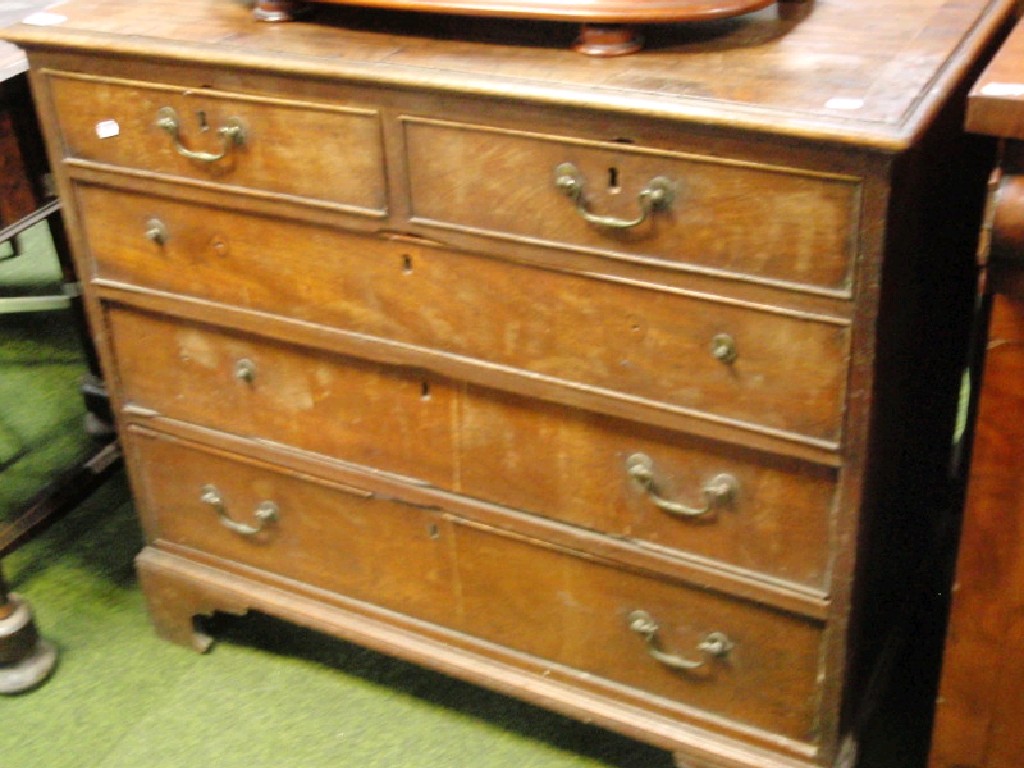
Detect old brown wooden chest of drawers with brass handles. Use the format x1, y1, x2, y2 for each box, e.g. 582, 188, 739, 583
7, 0, 1010, 768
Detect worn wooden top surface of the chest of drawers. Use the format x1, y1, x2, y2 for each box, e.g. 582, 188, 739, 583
0, 0, 1013, 150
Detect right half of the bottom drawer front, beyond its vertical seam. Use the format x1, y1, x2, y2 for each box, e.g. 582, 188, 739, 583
456, 525, 821, 740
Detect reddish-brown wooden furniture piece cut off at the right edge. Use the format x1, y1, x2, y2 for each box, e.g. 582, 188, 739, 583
929, 16, 1024, 768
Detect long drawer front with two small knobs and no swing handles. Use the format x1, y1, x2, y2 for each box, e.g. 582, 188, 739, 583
79, 186, 849, 447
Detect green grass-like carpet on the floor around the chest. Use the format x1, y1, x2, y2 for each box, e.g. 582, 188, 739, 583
0, 219, 932, 768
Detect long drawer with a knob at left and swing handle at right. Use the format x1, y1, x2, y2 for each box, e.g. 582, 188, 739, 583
106, 306, 836, 590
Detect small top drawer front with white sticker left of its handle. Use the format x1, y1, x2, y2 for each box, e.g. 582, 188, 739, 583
49, 74, 387, 215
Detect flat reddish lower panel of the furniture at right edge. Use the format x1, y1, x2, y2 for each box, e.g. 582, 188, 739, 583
930, 296, 1024, 768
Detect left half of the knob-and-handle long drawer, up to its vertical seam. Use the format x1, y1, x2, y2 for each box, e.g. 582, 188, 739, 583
108, 308, 454, 486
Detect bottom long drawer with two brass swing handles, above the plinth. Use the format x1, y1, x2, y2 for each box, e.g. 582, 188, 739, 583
128, 428, 821, 741
